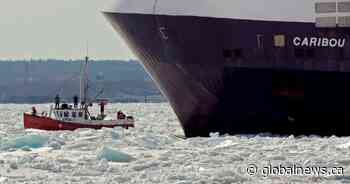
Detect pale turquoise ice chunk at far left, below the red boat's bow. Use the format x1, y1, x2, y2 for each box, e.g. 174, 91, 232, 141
1, 135, 49, 150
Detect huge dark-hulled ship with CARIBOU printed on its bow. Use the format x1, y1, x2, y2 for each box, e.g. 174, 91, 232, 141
103, 0, 350, 137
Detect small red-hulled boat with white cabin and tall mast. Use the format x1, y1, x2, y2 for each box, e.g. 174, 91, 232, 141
23, 56, 135, 131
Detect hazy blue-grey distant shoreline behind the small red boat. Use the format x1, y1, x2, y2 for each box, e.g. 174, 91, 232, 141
0, 59, 166, 104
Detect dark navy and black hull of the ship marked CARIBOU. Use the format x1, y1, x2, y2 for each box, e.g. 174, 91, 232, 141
105, 13, 350, 137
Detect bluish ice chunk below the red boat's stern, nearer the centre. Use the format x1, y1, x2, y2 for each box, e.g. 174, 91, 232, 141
97, 147, 134, 162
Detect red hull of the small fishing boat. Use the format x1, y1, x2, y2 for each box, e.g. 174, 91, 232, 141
23, 113, 134, 131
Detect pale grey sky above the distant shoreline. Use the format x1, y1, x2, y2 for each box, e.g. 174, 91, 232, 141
0, 0, 135, 60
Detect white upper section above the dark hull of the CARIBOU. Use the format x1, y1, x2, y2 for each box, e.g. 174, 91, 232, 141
104, 0, 350, 22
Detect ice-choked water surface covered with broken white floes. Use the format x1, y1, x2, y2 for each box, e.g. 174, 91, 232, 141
0, 104, 350, 184
